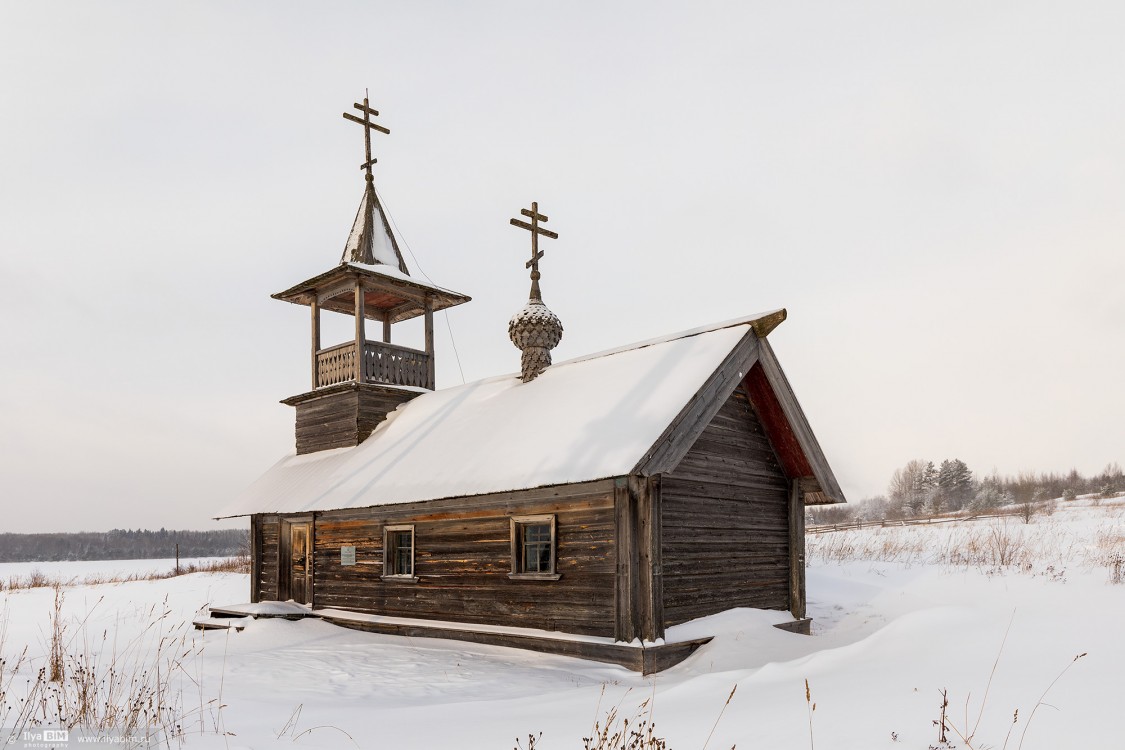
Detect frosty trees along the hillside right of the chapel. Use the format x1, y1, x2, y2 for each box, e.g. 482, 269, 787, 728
808, 459, 1125, 523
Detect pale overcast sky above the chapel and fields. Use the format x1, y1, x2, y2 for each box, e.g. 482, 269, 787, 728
0, 0, 1125, 532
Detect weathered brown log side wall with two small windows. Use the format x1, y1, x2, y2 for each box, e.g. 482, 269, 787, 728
262, 480, 617, 635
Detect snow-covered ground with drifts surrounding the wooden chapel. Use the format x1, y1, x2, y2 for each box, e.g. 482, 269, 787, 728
0, 505, 1125, 750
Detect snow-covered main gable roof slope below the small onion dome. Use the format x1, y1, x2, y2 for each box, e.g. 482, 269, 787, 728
219, 310, 784, 517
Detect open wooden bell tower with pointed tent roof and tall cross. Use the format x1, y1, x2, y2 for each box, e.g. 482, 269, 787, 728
272, 91, 469, 453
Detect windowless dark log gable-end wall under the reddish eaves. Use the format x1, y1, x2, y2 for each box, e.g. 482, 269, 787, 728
660, 387, 790, 625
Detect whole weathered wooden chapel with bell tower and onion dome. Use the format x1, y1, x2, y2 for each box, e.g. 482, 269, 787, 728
219, 93, 845, 672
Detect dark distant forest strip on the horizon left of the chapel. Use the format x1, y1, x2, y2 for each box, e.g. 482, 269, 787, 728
0, 528, 250, 562
